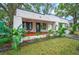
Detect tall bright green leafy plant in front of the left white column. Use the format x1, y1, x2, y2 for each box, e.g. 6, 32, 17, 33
12, 28, 25, 49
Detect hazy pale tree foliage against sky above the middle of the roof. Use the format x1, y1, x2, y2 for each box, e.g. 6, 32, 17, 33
24, 3, 53, 14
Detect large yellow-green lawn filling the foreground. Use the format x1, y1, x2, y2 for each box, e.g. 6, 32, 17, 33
0, 38, 79, 55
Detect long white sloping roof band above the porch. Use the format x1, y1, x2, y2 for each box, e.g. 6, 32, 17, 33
16, 9, 68, 23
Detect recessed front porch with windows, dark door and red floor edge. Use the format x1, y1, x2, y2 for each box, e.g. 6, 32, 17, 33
22, 18, 55, 36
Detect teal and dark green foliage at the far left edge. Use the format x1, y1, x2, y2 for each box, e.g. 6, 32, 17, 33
0, 21, 11, 44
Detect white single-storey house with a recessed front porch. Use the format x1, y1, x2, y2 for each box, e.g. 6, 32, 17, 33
13, 9, 69, 41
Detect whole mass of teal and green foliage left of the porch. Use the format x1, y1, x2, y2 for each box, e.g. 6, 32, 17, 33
0, 21, 25, 49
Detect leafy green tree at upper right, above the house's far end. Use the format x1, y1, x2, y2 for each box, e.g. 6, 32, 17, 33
55, 3, 79, 24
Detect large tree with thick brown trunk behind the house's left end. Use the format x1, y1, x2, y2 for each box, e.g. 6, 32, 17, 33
0, 3, 22, 27
